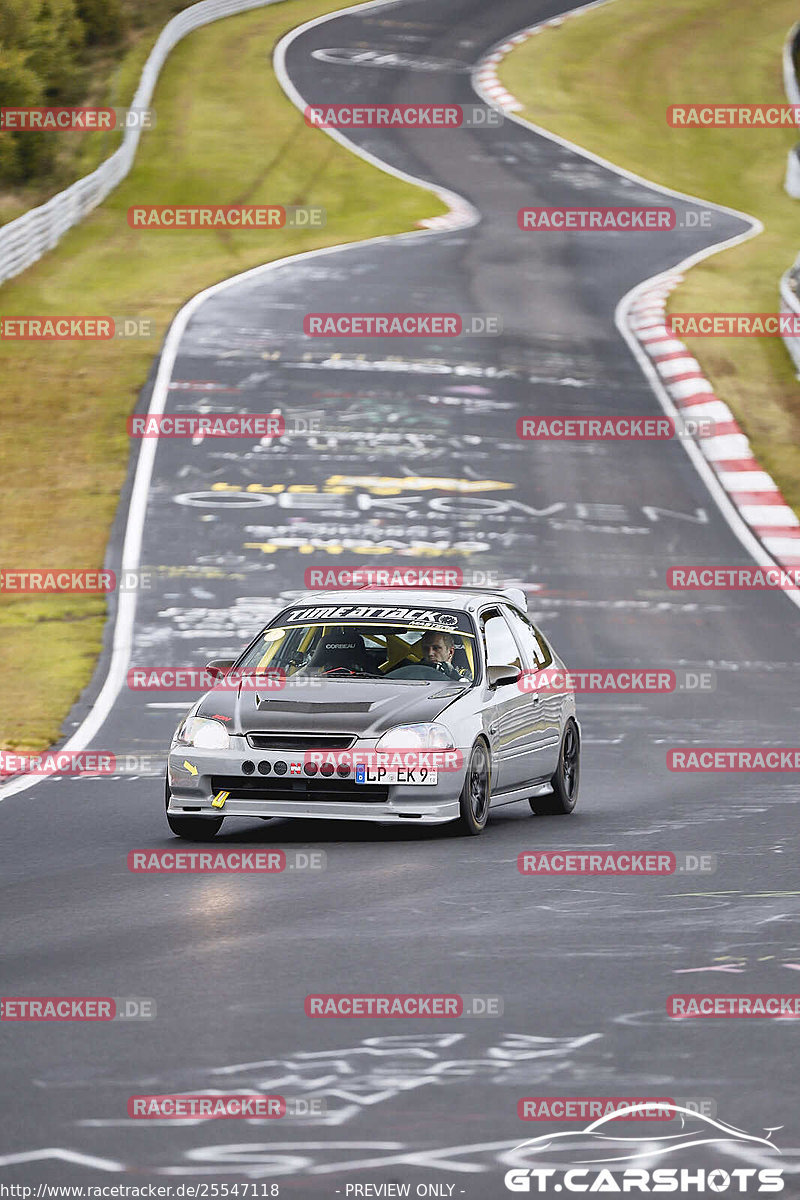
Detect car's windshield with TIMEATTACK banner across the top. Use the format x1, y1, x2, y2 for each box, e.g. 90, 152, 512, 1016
236, 605, 480, 684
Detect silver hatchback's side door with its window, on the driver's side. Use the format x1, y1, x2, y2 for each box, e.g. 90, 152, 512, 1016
480, 606, 533, 793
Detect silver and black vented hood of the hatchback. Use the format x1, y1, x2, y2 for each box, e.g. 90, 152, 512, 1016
198, 678, 467, 738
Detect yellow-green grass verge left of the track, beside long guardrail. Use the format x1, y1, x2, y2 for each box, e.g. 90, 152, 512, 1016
0, 0, 444, 751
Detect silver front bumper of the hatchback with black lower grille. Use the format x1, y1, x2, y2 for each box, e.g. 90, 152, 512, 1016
167, 746, 465, 824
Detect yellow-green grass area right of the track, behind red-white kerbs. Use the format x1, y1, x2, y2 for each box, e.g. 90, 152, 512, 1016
500, 0, 800, 501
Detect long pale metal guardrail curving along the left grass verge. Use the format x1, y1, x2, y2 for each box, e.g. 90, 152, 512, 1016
0, 0, 276, 283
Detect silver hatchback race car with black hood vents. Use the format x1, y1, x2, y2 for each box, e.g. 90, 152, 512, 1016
166, 587, 581, 841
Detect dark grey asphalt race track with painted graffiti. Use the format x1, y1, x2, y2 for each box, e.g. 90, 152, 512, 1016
0, 0, 800, 1198
